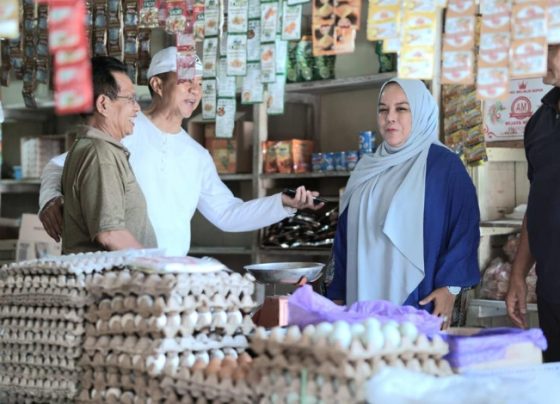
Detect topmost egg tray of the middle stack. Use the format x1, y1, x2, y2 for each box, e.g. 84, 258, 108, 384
88, 269, 255, 297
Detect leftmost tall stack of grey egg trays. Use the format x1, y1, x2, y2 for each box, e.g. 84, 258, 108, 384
0, 251, 152, 403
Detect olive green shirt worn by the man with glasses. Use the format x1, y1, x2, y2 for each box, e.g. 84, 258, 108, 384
62, 126, 157, 254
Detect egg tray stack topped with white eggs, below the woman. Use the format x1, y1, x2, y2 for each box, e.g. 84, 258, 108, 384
251, 318, 452, 403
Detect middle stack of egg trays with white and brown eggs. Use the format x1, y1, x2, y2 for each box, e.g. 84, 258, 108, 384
79, 260, 255, 402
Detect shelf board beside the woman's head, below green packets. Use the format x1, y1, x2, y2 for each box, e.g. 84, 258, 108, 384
286, 72, 396, 94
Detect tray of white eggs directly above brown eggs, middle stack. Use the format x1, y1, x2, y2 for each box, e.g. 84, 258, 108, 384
83, 334, 249, 355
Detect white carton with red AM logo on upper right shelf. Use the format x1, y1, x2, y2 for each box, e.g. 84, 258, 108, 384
483, 78, 552, 142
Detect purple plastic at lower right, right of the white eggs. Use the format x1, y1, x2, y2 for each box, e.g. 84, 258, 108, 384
441, 327, 547, 368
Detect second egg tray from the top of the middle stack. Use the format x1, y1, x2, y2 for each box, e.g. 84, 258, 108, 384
85, 293, 257, 323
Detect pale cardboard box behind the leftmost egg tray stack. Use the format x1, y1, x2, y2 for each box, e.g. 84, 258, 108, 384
16, 213, 62, 261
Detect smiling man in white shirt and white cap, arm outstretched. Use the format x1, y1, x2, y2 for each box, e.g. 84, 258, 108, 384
39, 47, 323, 256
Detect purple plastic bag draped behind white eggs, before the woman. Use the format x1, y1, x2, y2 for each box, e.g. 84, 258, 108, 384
288, 285, 442, 336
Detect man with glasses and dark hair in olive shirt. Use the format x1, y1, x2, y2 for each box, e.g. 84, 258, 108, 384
62, 56, 157, 254
